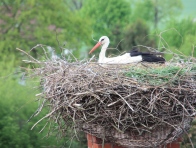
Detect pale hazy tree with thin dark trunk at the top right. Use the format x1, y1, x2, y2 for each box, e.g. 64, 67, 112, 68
132, 0, 182, 29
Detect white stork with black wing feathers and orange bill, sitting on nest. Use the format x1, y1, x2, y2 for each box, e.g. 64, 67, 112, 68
89, 36, 165, 64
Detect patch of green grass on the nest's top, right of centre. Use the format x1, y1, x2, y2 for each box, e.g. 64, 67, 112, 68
125, 65, 196, 86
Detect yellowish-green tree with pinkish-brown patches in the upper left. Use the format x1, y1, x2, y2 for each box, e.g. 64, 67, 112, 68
0, 0, 90, 63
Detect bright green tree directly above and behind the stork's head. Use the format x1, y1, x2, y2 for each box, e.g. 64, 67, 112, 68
80, 0, 131, 51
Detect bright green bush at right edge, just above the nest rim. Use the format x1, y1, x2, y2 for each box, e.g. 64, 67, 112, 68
160, 18, 196, 59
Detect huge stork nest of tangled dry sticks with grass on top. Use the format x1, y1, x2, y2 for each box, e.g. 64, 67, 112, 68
24, 51, 196, 147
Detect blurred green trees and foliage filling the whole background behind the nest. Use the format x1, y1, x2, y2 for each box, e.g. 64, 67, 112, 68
0, 0, 196, 148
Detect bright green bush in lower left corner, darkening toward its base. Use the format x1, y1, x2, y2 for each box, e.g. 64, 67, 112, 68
0, 77, 56, 148
